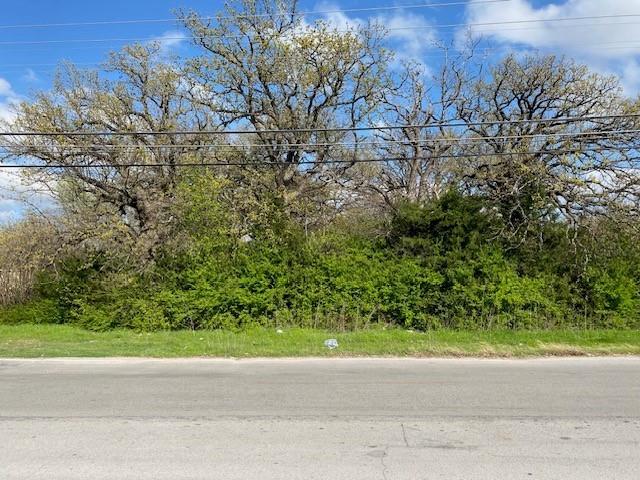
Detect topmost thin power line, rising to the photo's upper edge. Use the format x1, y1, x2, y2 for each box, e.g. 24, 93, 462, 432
0, 0, 512, 30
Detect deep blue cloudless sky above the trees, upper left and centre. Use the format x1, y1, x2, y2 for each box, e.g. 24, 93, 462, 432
0, 0, 480, 94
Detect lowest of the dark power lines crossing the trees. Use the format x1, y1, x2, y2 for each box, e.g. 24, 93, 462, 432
0, 147, 628, 169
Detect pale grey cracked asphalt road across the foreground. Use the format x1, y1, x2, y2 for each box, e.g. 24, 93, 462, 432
0, 358, 640, 480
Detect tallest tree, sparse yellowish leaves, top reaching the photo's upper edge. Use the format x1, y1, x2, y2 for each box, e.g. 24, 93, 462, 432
181, 0, 389, 210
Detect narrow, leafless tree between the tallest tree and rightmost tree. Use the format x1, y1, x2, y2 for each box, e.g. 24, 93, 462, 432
368, 49, 473, 207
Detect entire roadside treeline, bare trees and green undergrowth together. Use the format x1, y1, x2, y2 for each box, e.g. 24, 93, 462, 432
0, 0, 640, 330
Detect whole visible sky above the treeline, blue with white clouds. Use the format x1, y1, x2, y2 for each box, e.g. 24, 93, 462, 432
0, 0, 640, 223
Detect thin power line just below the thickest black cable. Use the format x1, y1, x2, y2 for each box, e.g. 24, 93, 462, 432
0, 129, 640, 150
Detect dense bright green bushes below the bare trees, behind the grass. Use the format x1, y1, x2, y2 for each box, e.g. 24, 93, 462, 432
3, 189, 640, 331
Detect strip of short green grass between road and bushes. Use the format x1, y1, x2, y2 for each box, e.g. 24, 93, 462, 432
0, 325, 640, 358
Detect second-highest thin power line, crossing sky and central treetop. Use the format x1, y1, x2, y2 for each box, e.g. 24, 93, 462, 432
0, 13, 640, 46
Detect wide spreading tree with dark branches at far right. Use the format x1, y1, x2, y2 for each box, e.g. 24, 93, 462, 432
456, 56, 640, 240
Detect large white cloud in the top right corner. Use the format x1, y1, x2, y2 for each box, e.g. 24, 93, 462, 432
459, 0, 640, 93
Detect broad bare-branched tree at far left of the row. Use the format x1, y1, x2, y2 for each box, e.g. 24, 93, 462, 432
1, 44, 211, 262
